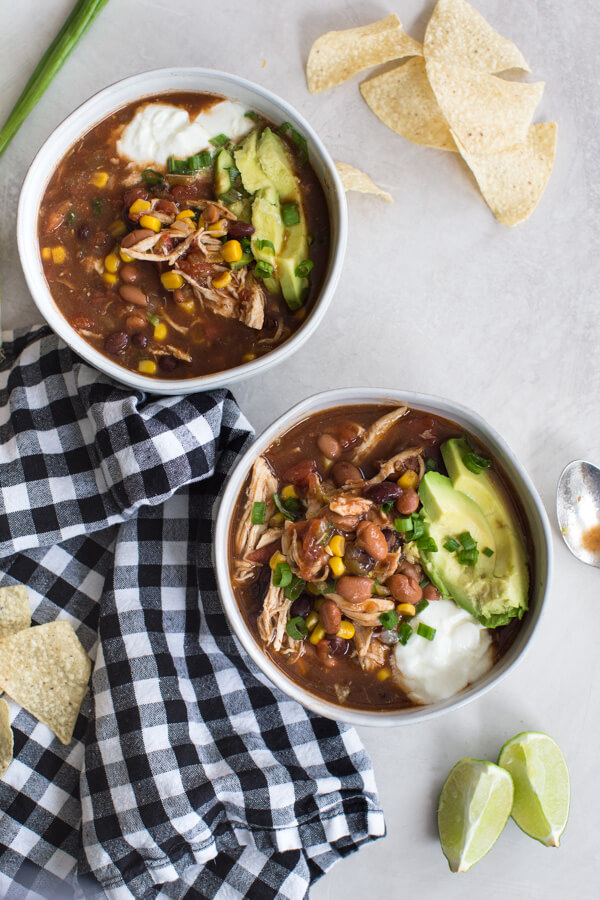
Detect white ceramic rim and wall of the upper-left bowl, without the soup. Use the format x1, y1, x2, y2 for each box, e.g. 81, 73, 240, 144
17, 68, 347, 394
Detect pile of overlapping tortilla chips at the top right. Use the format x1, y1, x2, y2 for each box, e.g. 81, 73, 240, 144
306, 0, 557, 225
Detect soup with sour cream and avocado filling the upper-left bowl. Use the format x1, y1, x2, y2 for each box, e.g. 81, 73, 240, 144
39, 93, 329, 378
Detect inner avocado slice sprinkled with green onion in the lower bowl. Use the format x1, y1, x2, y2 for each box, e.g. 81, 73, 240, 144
419, 472, 526, 628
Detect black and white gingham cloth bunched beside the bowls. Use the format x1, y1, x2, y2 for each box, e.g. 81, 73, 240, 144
0, 327, 384, 900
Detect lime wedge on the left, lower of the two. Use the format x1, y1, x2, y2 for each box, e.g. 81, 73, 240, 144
438, 759, 513, 872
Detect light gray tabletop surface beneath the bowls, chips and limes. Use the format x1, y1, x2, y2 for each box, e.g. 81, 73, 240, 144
0, 0, 600, 900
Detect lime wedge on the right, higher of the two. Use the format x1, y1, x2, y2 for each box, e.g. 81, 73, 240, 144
498, 731, 571, 847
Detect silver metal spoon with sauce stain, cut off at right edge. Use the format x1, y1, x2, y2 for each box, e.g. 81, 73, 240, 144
556, 459, 600, 568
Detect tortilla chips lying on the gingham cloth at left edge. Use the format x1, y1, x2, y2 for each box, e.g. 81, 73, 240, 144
0, 586, 92, 777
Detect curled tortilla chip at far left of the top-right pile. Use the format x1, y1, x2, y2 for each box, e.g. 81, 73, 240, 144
306, 13, 423, 94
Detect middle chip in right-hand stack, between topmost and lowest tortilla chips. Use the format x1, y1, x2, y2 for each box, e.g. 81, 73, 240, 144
426, 62, 544, 153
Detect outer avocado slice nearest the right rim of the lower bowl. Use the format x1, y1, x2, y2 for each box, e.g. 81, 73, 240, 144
441, 438, 529, 612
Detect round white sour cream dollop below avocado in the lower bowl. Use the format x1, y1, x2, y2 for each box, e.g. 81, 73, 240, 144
394, 600, 494, 703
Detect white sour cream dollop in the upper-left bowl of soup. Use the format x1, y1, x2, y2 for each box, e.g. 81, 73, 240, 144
117, 100, 254, 166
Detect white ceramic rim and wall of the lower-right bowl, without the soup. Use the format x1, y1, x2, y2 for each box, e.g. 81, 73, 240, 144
213, 388, 552, 726
